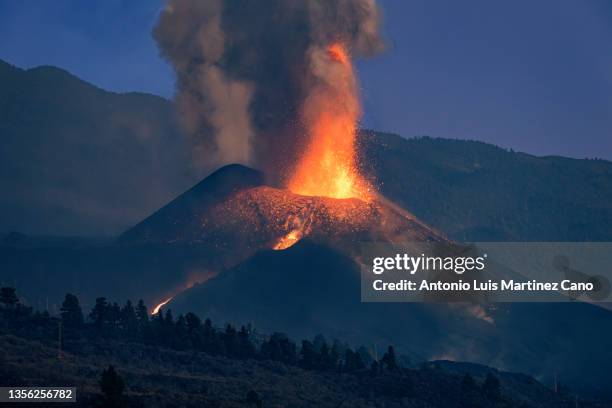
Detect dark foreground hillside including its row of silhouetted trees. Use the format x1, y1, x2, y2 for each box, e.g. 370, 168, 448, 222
0, 288, 598, 408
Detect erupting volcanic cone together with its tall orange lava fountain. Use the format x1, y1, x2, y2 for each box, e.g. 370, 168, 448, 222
124, 42, 444, 255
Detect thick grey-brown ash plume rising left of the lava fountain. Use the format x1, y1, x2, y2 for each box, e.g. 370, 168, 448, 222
153, 0, 383, 174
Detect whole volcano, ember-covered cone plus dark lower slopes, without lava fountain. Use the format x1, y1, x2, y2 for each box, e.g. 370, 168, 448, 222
119, 165, 612, 398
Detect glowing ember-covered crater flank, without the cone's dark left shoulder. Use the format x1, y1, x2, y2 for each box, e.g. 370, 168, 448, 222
202, 186, 442, 250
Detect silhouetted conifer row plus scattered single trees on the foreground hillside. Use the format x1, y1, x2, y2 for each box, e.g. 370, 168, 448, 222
0, 287, 527, 408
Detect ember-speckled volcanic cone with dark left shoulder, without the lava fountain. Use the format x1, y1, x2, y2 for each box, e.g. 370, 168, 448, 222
120, 165, 446, 253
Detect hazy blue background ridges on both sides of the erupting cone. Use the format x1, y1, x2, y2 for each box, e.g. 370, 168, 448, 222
0, 61, 612, 241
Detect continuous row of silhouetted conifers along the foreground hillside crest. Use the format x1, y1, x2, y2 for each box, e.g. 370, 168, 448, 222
0, 288, 400, 374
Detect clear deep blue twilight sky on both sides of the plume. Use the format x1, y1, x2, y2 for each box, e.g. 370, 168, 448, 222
0, 0, 612, 159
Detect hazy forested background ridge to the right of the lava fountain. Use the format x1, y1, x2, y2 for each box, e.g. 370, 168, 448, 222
362, 132, 612, 241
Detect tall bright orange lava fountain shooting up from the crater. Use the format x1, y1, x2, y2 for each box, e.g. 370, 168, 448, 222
288, 43, 371, 201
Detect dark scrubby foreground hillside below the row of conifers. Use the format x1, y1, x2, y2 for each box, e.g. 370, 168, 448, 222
0, 334, 592, 408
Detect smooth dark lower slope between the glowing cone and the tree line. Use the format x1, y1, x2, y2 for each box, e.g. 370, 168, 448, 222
167, 241, 612, 396
